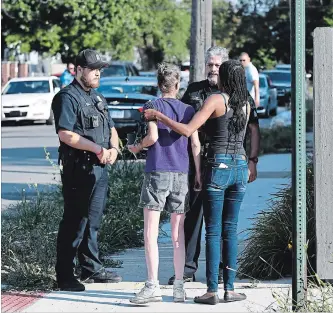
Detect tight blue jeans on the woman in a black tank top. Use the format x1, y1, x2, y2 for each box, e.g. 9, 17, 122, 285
203, 154, 248, 292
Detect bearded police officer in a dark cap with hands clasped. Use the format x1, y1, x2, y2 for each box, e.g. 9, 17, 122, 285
52, 49, 121, 291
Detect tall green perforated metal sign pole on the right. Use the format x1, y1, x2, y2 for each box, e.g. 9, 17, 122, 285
290, 0, 307, 311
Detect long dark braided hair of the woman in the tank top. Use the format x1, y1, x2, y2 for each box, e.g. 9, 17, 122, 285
219, 60, 248, 135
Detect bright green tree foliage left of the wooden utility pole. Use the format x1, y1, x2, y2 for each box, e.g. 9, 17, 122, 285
1, 0, 190, 65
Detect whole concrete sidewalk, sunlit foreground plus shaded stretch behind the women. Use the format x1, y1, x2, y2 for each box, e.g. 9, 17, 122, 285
5, 154, 291, 312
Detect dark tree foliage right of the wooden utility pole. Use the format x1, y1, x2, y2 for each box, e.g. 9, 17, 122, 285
213, 0, 333, 70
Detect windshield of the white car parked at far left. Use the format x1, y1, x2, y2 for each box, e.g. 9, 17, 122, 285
2, 80, 50, 95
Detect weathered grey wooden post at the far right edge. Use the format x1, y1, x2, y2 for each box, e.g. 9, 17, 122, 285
313, 27, 333, 280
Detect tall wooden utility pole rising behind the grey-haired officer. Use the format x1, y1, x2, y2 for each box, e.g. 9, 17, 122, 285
190, 0, 212, 83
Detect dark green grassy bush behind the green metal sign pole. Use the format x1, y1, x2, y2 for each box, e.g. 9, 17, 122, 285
239, 164, 316, 279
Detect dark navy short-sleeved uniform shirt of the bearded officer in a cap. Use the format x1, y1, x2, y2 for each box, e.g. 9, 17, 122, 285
52, 79, 114, 149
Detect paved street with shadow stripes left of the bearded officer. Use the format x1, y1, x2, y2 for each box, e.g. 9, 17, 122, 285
1, 107, 284, 208
